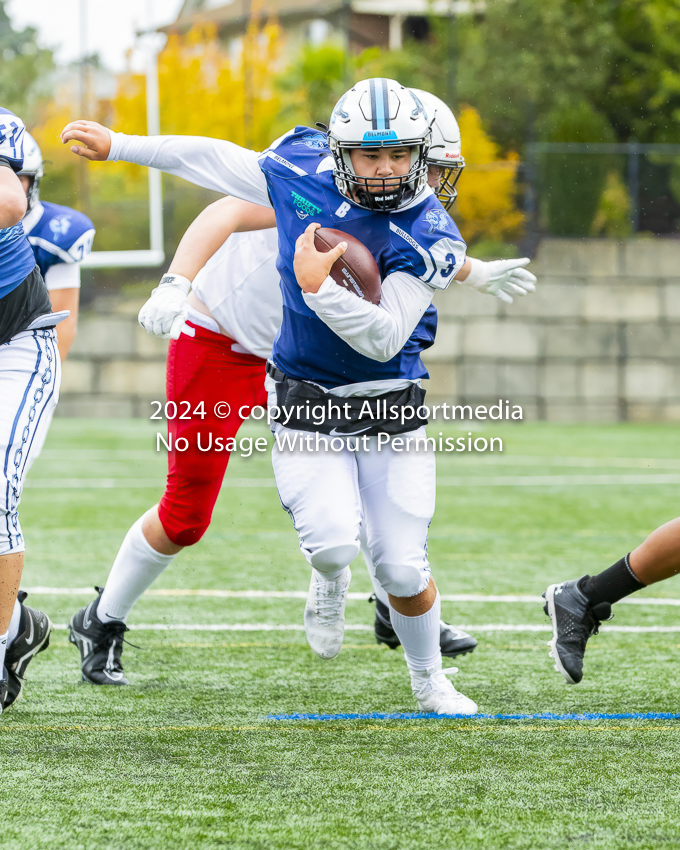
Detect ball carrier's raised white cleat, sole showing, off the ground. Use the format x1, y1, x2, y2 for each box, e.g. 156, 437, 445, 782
305, 567, 352, 658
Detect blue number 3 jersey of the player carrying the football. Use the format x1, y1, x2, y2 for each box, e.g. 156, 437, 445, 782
260, 127, 464, 388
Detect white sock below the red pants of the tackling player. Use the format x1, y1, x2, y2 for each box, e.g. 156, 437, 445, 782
97, 516, 175, 623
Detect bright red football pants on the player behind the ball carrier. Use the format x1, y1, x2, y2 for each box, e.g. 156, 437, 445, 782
158, 322, 267, 546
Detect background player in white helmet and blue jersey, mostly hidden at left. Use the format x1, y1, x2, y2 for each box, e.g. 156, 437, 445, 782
19, 132, 95, 363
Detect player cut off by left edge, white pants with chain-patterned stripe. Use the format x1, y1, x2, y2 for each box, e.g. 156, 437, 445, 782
0, 108, 60, 712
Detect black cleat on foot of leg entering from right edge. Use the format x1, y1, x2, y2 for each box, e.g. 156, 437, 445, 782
543, 579, 613, 685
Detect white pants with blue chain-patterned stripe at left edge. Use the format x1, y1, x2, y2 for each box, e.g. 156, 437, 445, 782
0, 328, 61, 555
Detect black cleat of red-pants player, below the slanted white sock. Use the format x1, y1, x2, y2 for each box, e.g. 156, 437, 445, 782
68, 587, 130, 685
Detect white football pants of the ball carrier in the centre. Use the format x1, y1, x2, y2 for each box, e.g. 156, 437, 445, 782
272, 425, 436, 597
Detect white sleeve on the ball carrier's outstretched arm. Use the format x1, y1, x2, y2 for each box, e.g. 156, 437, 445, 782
108, 130, 271, 207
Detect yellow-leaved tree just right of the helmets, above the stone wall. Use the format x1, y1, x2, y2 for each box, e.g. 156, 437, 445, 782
454, 106, 524, 243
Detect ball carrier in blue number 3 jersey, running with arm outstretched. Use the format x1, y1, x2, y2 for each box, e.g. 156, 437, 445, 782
62, 79, 529, 714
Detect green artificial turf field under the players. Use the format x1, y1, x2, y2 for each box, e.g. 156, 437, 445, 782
0, 419, 680, 850
